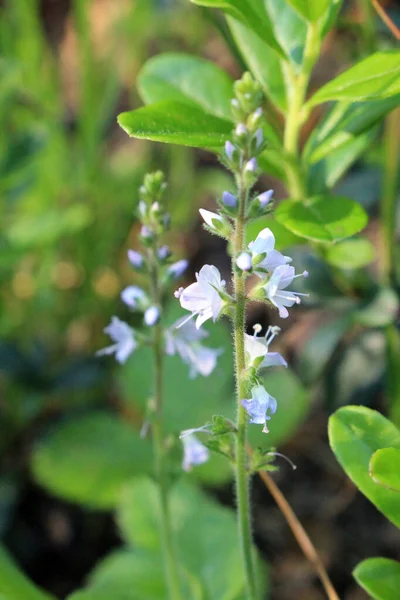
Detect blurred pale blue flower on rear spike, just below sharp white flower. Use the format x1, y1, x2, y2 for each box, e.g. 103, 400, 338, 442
165, 317, 222, 379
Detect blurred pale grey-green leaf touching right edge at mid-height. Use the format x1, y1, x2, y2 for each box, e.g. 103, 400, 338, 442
354, 287, 399, 327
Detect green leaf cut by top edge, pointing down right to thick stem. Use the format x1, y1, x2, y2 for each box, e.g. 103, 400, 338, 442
191, 0, 283, 55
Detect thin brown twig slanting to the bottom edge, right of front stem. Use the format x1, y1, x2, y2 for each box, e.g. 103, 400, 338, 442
247, 446, 340, 600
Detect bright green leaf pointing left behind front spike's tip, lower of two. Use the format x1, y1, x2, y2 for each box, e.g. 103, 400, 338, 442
118, 100, 233, 148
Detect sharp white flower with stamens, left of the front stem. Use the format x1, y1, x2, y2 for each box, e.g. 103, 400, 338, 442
175, 265, 225, 329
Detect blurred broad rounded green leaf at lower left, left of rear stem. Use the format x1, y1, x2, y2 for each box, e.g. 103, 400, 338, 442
32, 412, 151, 509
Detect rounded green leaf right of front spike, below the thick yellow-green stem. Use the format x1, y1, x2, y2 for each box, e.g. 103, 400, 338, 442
275, 196, 368, 243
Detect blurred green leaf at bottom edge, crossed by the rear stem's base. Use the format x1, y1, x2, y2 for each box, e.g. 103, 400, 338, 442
69, 548, 204, 600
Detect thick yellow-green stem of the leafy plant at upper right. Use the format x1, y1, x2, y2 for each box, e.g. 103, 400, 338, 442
283, 23, 321, 200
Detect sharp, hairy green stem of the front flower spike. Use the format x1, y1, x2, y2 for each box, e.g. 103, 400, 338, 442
232, 181, 257, 600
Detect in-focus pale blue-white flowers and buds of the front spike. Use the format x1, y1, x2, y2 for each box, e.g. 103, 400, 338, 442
175, 74, 308, 465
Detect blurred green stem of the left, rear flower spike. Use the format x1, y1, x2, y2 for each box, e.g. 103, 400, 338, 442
149, 250, 182, 600
